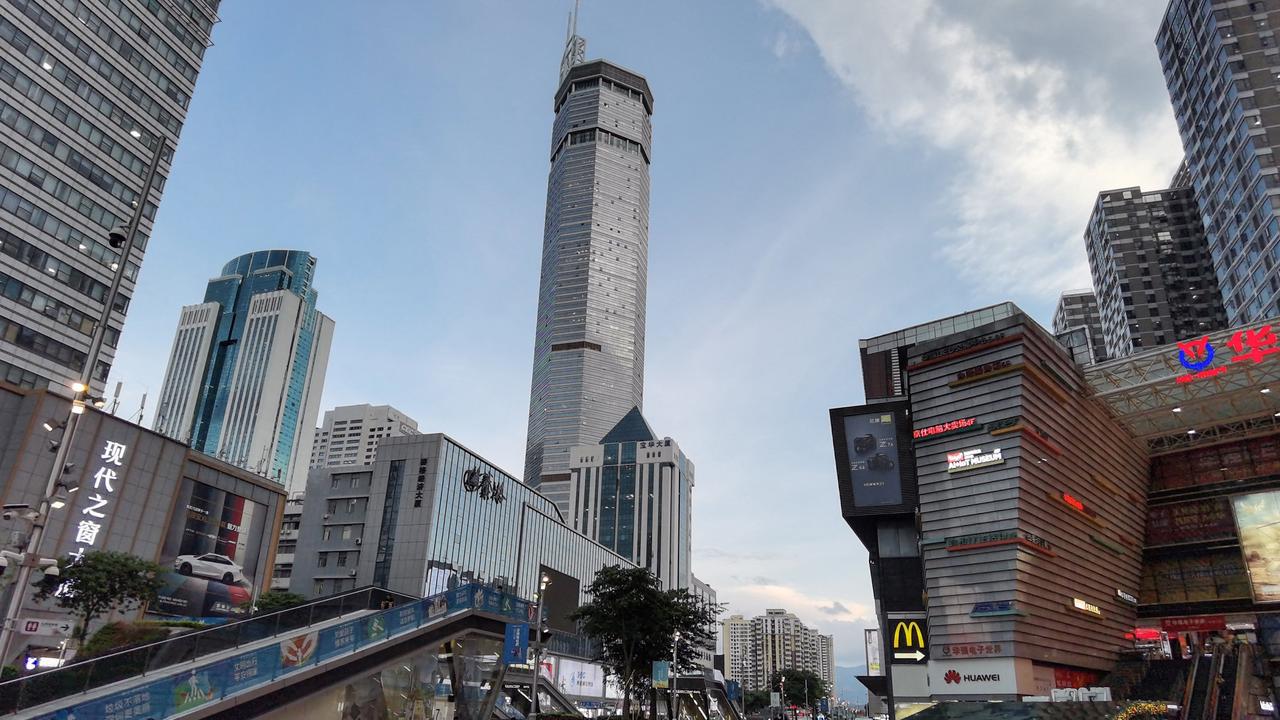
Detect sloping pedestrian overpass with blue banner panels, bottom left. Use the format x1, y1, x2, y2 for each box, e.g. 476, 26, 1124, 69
0, 584, 577, 720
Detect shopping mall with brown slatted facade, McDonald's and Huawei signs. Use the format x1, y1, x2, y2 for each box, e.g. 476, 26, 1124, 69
831, 304, 1280, 716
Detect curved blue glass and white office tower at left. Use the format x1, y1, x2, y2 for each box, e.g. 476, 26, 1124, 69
155, 250, 333, 489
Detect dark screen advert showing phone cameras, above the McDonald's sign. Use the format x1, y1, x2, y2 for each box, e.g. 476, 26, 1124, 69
845, 413, 902, 507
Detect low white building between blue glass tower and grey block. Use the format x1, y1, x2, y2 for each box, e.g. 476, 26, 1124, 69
311, 404, 421, 468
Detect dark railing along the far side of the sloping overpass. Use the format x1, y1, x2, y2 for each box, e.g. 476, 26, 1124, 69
0, 587, 417, 715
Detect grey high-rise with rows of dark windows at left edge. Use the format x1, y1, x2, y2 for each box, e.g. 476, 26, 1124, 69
0, 0, 219, 389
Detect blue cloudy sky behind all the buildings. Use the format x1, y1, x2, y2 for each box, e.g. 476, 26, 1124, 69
104, 0, 1181, 665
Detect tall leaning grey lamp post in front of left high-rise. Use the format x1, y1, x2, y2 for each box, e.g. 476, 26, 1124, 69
0, 135, 168, 662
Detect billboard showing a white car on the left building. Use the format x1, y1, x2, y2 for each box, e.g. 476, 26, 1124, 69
148, 479, 268, 618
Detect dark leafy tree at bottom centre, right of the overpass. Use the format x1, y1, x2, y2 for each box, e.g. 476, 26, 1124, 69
573, 565, 719, 717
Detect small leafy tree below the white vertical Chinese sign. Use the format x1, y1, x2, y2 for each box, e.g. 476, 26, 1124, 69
36, 550, 165, 643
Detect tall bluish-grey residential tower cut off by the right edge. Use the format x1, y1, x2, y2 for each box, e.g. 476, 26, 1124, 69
1162, 0, 1280, 325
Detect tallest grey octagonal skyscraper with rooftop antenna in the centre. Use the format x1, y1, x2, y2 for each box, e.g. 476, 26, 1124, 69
525, 22, 653, 505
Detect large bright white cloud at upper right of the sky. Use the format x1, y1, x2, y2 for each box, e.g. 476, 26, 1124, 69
769, 0, 1180, 296
